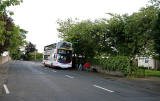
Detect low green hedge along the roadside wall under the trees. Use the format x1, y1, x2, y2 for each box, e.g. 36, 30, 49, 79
87, 56, 148, 77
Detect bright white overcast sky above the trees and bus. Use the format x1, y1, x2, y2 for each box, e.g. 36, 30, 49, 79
9, 0, 148, 52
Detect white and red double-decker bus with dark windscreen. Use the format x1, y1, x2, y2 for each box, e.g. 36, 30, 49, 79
43, 42, 72, 68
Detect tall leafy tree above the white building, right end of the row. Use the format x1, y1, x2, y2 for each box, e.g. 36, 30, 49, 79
125, 6, 157, 56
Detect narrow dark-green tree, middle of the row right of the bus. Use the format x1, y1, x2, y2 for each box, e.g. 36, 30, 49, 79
103, 14, 127, 55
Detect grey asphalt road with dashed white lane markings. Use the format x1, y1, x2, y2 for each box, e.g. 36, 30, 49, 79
0, 61, 160, 101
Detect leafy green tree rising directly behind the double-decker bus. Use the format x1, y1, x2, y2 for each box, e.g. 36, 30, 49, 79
58, 19, 105, 58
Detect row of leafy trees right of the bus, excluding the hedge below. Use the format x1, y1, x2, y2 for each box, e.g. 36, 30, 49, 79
58, 5, 159, 58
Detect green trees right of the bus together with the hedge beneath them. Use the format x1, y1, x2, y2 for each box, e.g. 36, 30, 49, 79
58, 0, 160, 76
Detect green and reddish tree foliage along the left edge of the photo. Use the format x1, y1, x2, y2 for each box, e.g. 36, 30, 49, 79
0, 0, 27, 56
